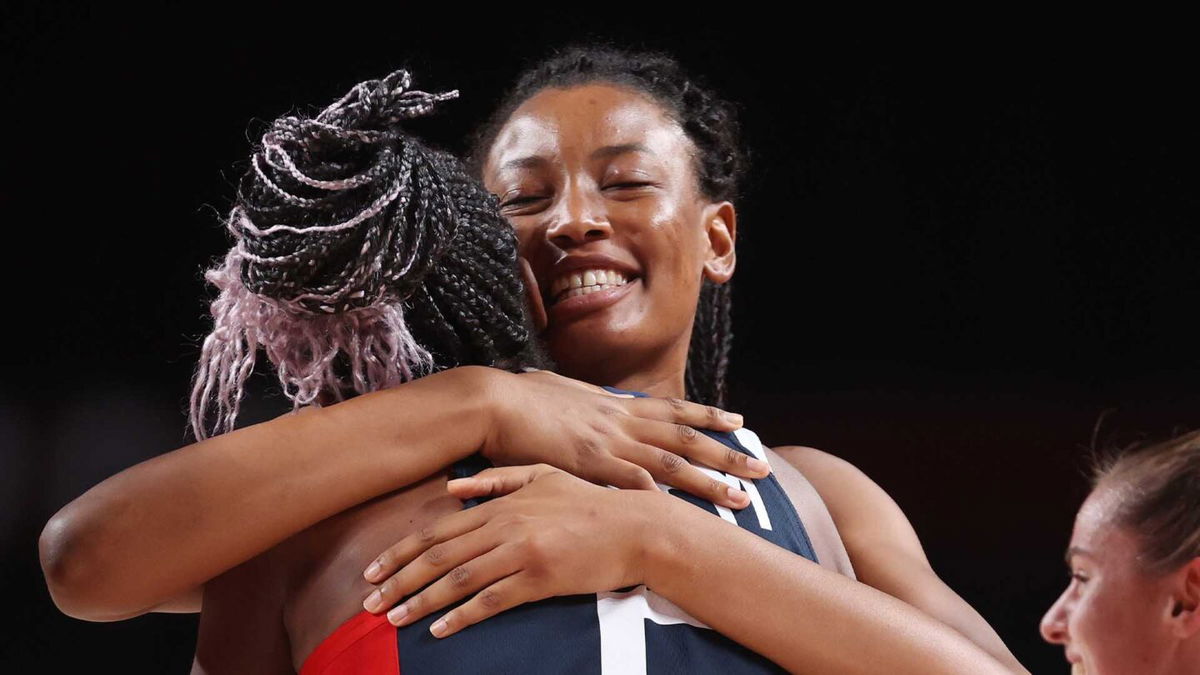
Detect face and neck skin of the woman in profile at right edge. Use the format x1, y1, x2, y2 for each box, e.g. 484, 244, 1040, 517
1042, 485, 1200, 675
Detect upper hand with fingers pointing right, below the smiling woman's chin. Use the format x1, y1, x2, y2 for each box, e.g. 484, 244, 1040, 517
482, 371, 770, 508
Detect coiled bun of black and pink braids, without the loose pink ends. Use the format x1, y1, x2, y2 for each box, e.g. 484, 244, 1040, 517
228, 71, 458, 313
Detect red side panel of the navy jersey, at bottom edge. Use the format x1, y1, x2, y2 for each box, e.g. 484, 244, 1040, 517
300, 610, 400, 675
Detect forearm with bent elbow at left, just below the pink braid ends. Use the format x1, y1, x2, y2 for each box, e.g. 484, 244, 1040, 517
38, 369, 488, 621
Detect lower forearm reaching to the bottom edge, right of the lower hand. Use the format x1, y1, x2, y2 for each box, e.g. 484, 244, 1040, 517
646, 495, 1027, 674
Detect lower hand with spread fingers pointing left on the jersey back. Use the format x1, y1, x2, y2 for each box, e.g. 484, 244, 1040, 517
362, 465, 673, 638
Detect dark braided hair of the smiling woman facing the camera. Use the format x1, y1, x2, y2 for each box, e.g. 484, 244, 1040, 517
470, 46, 748, 406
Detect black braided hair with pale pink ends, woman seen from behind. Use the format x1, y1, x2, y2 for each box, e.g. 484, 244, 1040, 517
191, 71, 544, 438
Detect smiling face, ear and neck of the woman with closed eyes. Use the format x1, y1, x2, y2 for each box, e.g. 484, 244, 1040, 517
484, 84, 734, 395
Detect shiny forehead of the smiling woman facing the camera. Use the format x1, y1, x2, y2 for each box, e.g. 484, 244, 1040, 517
487, 84, 688, 174
